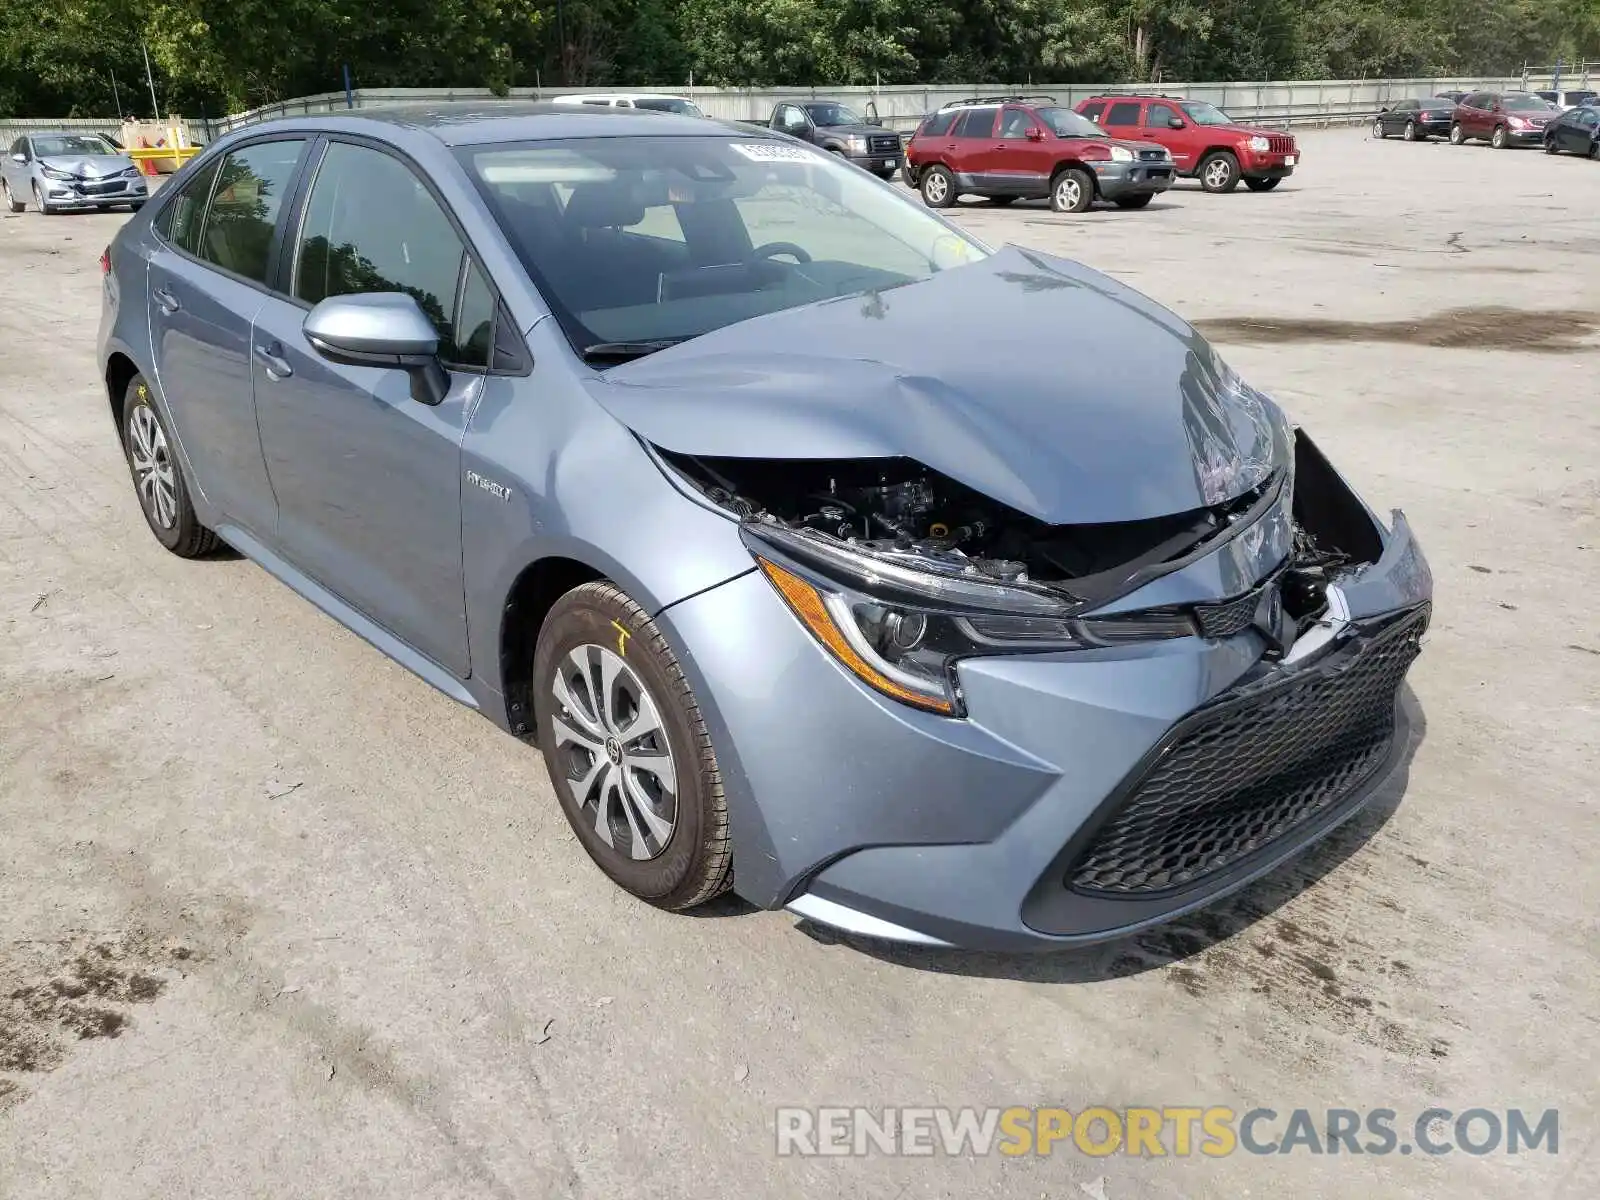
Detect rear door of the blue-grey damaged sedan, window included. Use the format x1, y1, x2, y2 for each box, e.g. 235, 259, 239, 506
149, 138, 307, 534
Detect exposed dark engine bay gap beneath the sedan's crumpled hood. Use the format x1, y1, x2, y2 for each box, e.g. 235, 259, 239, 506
661, 437, 1382, 640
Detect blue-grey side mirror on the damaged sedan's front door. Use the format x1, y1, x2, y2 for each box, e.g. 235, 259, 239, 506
301, 291, 450, 405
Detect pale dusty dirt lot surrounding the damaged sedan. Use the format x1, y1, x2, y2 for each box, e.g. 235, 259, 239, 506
0, 131, 1600, 1200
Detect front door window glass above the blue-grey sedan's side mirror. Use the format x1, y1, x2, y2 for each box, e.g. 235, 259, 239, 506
291, 142, 472, 357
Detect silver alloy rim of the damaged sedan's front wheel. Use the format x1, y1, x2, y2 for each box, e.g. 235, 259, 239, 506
550, 643, 678, 861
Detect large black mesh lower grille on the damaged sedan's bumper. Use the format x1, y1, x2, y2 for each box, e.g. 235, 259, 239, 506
1066, 610, 1427, 894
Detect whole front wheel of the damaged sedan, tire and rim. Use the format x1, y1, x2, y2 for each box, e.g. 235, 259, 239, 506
533, 582, 733, 912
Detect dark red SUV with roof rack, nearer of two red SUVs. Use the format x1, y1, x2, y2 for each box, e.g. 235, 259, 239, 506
906, 96, 1173, 213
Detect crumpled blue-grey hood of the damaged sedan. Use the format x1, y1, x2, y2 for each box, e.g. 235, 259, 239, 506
586, 248, 1290, 525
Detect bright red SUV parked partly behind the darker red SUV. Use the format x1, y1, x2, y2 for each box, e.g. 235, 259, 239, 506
1078, 96, 1301, 192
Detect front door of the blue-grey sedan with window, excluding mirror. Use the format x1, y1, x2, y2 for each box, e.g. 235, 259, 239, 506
253, 141, 494, 678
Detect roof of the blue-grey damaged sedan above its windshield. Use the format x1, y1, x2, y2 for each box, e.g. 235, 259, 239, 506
222, 101, 752, 146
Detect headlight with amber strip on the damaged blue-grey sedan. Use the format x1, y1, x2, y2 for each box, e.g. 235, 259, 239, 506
741, 522, 1195, 717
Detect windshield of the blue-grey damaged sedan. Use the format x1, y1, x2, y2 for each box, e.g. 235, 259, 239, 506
459, 138, 989, 358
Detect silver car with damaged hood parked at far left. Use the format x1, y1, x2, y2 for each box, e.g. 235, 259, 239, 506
0, 133, 150, 216
